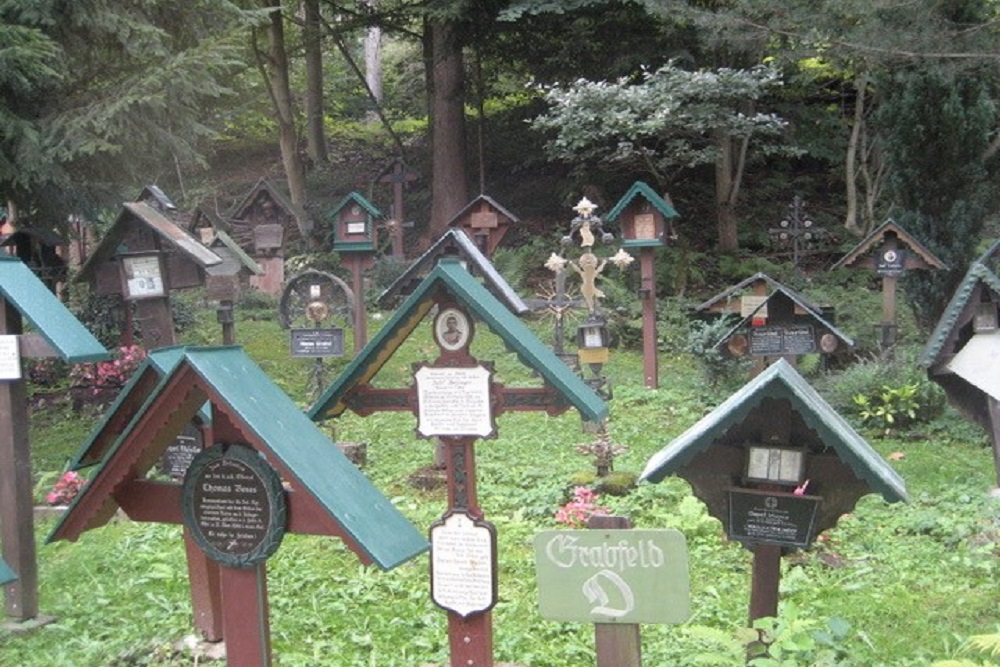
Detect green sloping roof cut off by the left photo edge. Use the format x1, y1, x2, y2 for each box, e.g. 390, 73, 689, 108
0, 253, 109, 364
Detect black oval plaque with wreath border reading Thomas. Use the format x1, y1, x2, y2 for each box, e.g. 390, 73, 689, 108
182, 444, 288, 568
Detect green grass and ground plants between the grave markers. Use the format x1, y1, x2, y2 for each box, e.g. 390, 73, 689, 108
0, 306, 1000, 667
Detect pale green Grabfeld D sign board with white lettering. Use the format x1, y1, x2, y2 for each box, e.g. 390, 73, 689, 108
535, 529, 691, 623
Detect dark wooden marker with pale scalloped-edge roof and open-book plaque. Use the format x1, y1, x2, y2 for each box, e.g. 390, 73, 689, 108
640, 359, 906, 625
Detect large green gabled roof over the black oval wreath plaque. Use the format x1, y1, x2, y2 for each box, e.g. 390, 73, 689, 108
49, 347, 428, 569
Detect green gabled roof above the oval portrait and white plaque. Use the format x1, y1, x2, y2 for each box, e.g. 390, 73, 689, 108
309, 257, 608, 421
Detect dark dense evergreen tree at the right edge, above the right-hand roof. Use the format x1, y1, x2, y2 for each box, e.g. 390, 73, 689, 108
876, 69, 1000, 327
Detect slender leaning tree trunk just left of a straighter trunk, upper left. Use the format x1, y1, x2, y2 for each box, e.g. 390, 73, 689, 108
262, 0, 307, 213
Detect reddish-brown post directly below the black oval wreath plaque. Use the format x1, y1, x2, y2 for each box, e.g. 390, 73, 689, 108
219, 563, 271, 667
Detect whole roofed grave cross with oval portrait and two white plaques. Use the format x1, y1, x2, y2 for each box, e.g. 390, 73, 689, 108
309, 258, 607, 667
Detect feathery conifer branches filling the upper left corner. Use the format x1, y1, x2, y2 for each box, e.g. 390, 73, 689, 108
0, 0, 246, 228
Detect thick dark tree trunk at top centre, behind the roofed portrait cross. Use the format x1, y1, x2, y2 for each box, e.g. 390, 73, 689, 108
424, 22, 469, 243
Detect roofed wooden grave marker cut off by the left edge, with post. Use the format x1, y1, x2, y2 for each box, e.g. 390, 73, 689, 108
0, 253, 109, 622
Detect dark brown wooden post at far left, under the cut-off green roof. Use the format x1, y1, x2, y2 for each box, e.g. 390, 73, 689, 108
0, 298, 38, 621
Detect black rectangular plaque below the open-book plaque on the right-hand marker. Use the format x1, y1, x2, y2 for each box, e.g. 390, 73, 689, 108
727, 489, 820, 548
